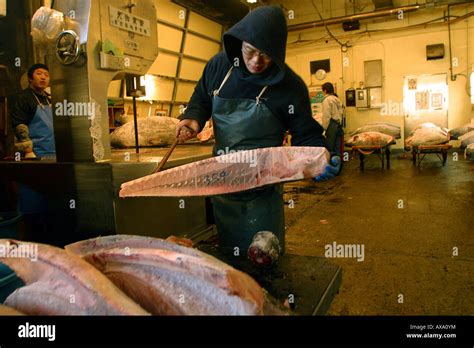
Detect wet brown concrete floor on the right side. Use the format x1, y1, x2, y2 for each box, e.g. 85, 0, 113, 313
285, 150, 474, 315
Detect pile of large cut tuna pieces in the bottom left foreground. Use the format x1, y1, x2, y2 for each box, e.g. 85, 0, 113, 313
0, 235, 268, 315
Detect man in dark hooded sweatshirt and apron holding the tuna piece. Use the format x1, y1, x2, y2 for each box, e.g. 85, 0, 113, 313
176, 6, 341, 252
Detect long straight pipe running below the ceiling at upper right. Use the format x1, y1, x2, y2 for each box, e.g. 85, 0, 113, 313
288, 5, 421, 31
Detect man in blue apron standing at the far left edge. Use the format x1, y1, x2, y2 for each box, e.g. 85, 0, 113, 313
10, 64, 56, 241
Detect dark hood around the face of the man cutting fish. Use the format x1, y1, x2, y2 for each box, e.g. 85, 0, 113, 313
224, 6, 288, 85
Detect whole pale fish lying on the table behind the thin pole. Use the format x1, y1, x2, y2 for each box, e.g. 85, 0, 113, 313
110, 116, 179, 148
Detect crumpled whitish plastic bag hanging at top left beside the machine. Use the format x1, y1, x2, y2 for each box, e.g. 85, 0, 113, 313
31, 6, 65, 46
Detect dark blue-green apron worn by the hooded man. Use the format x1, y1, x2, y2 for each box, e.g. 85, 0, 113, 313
211, 68, 285, 255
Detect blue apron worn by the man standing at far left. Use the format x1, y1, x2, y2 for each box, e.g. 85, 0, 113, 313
18, 100, 56, 214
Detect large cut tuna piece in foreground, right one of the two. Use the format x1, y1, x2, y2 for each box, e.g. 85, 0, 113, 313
66, 235, 264, 315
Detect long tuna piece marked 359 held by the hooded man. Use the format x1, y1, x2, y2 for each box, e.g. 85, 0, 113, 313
120, 146, 329, 197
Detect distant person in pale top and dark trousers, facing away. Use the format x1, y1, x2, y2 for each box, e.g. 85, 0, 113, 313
322, 82, 344, 167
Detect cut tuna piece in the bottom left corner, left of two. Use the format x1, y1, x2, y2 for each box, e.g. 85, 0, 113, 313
0, 239, 149, 315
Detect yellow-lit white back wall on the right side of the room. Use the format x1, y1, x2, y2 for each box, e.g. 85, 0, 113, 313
287, 4, 474, 147
